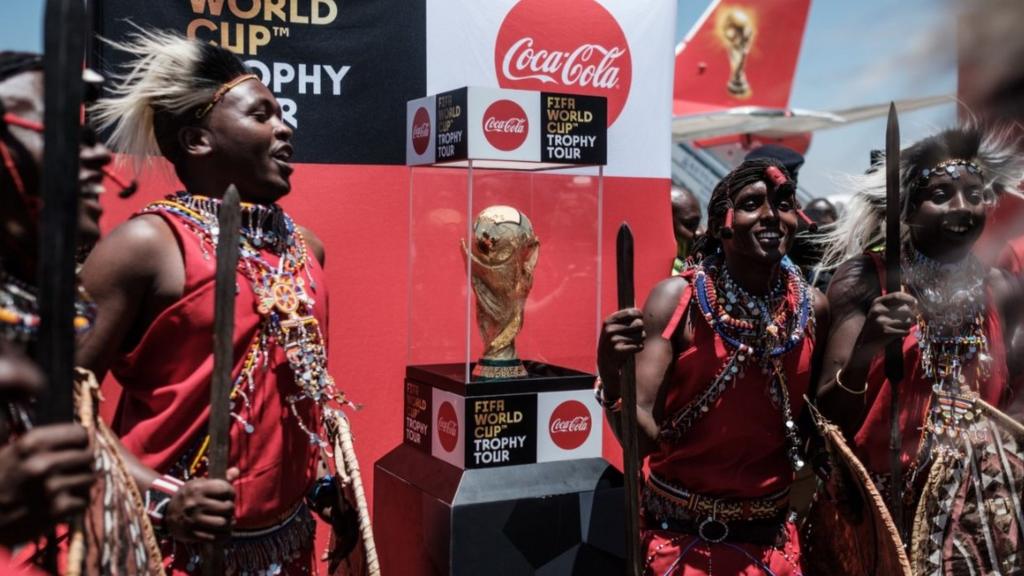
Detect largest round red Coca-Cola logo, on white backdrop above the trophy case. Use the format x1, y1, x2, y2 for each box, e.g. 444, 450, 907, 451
495, 0, 633, 126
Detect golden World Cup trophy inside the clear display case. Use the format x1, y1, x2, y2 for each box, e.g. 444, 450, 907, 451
462, 206, 541, 380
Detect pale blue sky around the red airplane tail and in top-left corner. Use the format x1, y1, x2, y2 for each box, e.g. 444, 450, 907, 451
0, 0, 956, 196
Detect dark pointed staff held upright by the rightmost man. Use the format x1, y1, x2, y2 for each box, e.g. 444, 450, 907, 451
885, 102, 903, 534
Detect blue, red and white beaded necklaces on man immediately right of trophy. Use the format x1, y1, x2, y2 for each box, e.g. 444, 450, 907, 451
662, 258, 814, 471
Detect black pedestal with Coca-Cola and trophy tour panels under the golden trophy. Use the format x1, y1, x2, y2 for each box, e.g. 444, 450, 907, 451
374, 362, 625, 576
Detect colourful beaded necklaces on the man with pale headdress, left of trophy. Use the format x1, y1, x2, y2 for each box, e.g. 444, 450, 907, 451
142, 193, 353, 471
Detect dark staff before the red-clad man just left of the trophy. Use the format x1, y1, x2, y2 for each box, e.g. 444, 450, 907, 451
204, 184, 242, 576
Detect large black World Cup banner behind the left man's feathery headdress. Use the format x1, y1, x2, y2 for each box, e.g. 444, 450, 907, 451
94, 0, 426, 164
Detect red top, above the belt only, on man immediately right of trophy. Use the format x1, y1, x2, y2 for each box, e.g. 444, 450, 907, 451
649, 276, 814, 498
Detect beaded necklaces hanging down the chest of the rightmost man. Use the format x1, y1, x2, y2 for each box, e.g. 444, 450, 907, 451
902, 245, 992, 456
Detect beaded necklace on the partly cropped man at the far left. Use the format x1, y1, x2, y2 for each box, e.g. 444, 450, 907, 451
0, 268, 96, 344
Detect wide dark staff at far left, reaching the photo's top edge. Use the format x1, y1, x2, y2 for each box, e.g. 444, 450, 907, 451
36, 0, 86, 574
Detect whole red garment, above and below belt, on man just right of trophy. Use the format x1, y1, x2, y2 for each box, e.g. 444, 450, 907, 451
645, 278, 814, 576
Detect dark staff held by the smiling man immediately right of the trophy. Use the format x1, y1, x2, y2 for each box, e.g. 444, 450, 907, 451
615, 222, 643, 576
